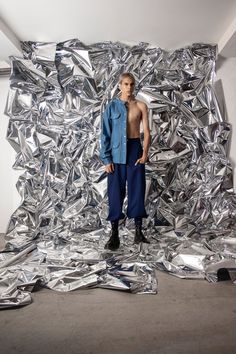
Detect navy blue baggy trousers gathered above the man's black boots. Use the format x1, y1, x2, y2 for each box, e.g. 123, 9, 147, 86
107, 138, 148, 221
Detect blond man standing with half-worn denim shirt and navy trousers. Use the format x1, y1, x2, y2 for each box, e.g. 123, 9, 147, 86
100, 73, 150, 250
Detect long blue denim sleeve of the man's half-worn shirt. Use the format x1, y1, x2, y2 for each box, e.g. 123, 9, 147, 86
100, 103, 112, 165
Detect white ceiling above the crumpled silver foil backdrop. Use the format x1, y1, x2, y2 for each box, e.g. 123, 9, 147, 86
0, 0, 236, 65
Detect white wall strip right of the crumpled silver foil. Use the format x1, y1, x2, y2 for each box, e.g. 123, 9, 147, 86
216, 56, 236, 192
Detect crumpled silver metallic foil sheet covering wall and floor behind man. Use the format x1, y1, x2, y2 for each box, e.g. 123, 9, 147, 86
0, 39, 236, 307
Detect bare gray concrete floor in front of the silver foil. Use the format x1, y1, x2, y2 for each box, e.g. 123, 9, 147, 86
0, 234, 236, 354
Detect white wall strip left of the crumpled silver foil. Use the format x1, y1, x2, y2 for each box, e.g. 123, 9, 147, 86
0, 77, 20, 233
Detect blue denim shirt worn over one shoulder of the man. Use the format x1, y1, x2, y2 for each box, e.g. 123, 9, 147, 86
100, 97, 127, 165
